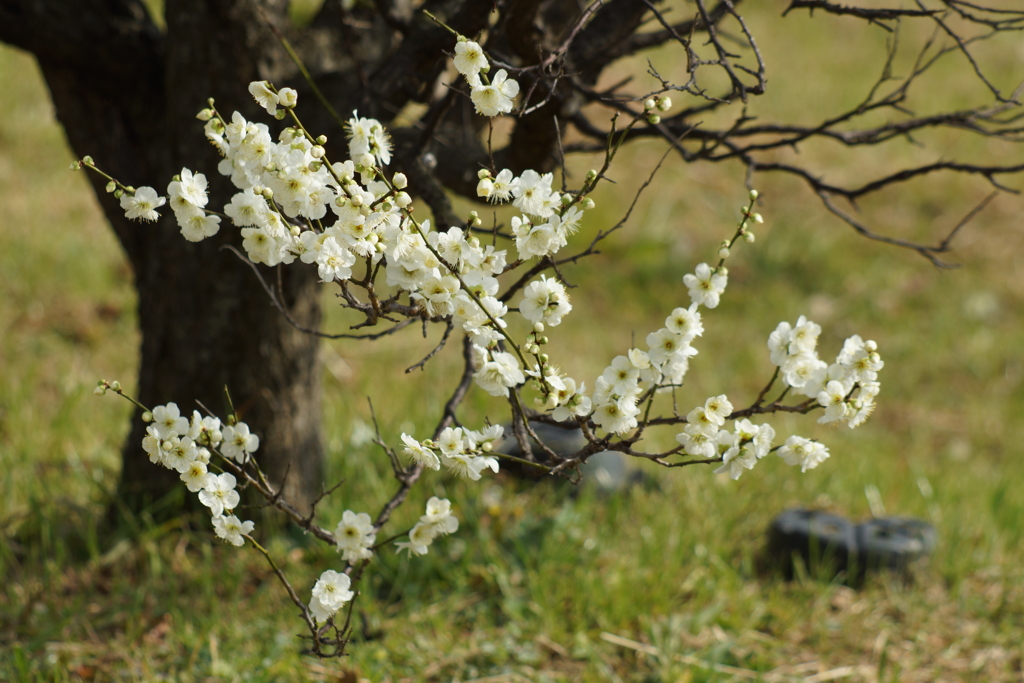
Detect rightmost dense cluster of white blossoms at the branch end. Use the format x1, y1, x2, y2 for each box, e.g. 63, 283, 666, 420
768, 315, 885, 428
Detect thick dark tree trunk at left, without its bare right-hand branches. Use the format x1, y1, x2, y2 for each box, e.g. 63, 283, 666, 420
0, 0, 324, 512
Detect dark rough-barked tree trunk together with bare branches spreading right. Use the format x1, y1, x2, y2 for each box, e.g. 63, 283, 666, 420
0, 0, 1024, 520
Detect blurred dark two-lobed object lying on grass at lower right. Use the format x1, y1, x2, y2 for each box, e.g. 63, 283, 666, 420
766, 509, 935, 586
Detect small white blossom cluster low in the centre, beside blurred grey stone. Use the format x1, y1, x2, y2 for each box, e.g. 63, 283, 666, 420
401, 428, 508, 481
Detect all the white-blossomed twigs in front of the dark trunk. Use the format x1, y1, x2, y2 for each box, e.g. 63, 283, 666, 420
66, 10, 897, 656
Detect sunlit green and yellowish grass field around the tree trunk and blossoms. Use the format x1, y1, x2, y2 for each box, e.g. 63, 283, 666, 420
0, 8, 1024, 683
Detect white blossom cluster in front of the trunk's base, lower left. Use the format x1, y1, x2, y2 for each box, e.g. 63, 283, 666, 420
142, 403, 259, 546
